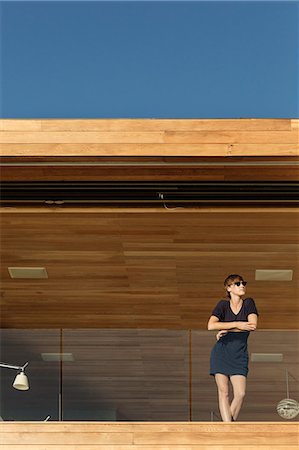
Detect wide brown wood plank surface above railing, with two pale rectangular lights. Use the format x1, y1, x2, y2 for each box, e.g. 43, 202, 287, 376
1, 208, 299, 329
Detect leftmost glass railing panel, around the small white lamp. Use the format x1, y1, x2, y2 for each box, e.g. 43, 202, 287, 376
0, 329, 60, 421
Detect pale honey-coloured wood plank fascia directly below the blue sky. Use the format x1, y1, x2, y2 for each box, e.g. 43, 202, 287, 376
0, 119, 299, 157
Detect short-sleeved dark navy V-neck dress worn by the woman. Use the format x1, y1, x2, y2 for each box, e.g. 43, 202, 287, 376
210, 297, 259, 377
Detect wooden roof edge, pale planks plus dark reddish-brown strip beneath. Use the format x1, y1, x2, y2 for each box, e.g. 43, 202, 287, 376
0, 119, 299, 185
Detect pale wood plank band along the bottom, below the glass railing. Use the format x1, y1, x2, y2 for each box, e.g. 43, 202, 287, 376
0, 422, 298, 450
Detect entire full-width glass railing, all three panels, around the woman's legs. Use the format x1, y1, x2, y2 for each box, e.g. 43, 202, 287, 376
0, 329, 299, 421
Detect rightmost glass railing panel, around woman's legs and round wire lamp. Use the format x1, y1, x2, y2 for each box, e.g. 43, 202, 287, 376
192, 330, 299, 421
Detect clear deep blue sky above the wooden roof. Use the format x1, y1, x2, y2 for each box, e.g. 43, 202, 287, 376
0, 0, 299, 118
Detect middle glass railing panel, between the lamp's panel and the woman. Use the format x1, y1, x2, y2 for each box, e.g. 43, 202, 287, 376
62, 329, 189, 421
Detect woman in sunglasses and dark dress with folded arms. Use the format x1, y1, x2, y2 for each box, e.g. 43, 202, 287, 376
208, 274, 258, 422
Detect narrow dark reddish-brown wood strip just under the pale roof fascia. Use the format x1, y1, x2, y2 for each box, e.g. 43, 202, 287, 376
0, 156, 299, 181
